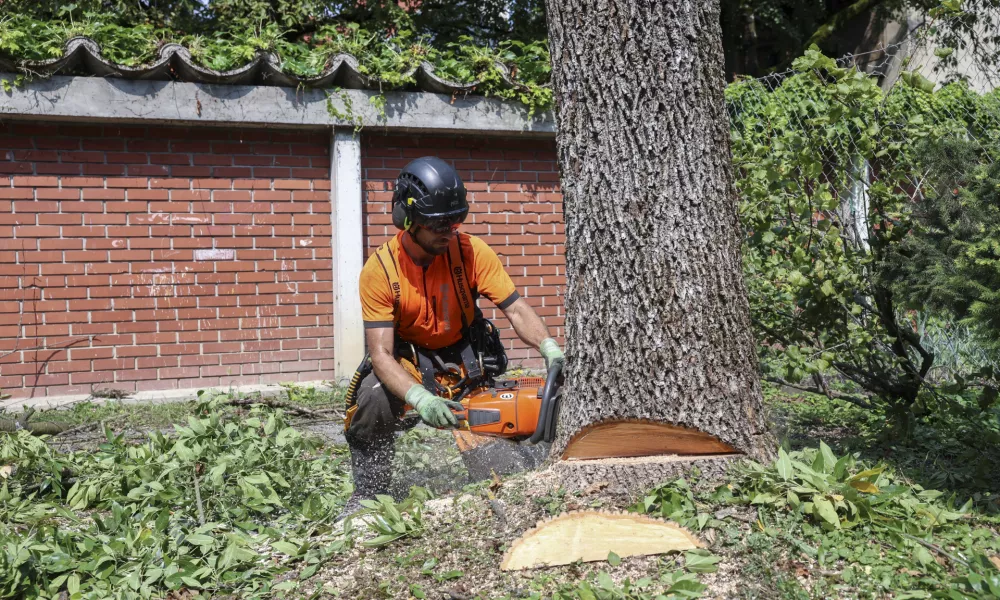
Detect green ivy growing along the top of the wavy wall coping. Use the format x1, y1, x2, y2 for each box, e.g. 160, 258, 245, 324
0, 13, 552, 115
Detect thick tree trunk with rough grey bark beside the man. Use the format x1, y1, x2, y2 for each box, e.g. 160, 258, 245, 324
547, 0, 773, 477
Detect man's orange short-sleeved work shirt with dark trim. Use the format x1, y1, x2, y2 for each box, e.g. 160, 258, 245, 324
360, 231, 520, 350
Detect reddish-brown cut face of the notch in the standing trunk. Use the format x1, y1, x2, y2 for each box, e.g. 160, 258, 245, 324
561, 420, 738, 460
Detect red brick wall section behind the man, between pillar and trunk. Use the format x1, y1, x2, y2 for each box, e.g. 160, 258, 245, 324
361, 135, 566, 368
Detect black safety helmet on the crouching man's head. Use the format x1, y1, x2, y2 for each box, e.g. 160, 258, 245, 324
392, 156, 469, 232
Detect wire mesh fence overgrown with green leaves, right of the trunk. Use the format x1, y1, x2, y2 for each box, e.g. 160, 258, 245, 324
726, 9, 1000, 386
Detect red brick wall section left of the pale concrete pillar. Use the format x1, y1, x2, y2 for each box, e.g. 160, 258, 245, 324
0, 123, 333, 397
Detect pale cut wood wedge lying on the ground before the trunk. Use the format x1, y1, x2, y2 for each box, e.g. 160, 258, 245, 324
500, 511, 702, 571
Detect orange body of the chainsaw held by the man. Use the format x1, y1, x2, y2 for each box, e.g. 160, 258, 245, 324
459, 377, 545, 439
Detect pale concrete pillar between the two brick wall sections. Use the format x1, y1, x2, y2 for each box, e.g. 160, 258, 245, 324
330, 128, 365, 383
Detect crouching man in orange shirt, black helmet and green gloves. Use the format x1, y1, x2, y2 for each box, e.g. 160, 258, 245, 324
339, 157, 563, 518
